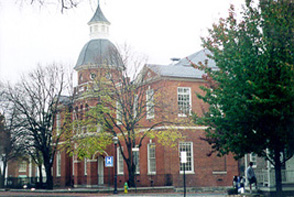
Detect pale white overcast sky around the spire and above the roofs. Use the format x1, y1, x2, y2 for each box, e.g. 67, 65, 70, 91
0, 0, 244, 82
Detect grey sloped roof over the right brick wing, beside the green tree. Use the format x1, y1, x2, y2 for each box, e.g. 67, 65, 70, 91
147, 50, 216, 78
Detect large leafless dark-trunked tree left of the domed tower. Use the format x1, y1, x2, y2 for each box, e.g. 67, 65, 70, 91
6, 64, 67, 189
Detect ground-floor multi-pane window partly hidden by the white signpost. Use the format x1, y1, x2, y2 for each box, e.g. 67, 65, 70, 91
179, 142, 194, 173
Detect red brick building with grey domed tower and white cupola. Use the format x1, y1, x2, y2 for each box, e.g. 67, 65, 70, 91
53, 2, 238, 187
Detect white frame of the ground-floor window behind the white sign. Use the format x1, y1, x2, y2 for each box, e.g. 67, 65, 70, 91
179, 142, 194, 174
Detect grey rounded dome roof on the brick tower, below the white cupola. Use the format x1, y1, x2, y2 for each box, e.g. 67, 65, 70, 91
74, 39, 123, 70
